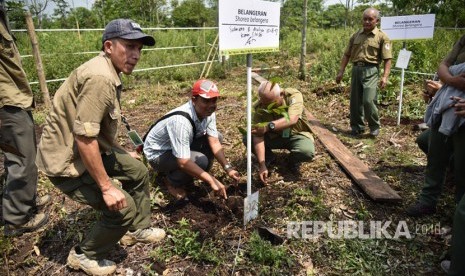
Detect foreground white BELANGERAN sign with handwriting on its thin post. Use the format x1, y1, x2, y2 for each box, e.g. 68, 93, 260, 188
218, 0, 280, 225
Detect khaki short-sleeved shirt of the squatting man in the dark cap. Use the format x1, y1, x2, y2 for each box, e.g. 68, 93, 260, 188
37, 52, 121, 177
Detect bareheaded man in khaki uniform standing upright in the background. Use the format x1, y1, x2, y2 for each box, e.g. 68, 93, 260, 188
336, 8, 392, 137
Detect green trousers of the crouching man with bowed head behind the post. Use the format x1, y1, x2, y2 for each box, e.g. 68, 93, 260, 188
265, 134, 315, 163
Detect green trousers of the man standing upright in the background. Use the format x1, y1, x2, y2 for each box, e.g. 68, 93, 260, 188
350, 65, 380, 132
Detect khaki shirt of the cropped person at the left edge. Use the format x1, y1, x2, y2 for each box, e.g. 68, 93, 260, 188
0, 1, 34, 110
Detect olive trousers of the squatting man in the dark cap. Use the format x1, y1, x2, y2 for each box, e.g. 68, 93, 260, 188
50, 148, 151, 260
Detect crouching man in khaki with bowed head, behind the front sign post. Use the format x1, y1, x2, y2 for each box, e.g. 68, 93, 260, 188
252, 81, 315, 185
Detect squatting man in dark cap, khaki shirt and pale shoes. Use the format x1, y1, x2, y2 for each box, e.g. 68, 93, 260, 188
37, 19, 165, 275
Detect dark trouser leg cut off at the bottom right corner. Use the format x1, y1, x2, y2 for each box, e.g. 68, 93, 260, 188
448, 193, 465, 276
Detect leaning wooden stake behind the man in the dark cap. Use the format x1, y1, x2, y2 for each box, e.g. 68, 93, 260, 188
26, 12, 51, 109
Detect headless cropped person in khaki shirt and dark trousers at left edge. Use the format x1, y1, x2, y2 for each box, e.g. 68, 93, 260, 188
0, 0, 50, 236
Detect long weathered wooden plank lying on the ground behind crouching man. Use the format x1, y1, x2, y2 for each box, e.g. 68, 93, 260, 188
252, 73, 402, 202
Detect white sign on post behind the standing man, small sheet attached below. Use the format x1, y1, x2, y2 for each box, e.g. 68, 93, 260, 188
381, 14, 435, 125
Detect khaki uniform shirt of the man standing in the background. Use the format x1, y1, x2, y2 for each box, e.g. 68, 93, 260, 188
344, 27, 392, 64
